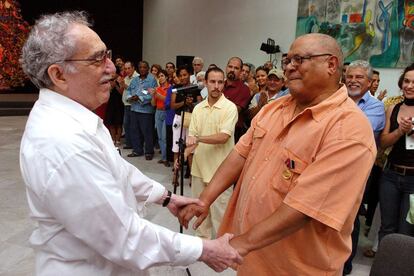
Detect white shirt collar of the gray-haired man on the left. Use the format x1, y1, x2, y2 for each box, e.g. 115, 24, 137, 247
39, 88, 103, 134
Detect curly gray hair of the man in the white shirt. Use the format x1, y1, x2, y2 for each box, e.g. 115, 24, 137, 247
20, 11, 92, 88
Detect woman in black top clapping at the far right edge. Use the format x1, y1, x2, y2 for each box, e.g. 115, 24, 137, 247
379, 63, 414, 242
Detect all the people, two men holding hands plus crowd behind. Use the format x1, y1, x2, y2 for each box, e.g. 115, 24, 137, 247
20, 9, 414, 275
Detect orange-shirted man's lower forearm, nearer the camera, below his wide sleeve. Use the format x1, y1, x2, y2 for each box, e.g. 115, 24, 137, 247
233, 203, 310, 255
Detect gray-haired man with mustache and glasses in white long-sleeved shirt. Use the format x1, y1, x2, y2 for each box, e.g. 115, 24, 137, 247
20, 12, 242, 276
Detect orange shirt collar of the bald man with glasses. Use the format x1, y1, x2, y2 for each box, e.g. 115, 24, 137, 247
284, 85, 348, 122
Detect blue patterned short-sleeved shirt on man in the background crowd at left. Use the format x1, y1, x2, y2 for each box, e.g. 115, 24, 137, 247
127, 74, 157, 113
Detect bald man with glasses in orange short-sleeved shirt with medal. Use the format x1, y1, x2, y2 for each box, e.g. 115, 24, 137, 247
180, 34, 376, 276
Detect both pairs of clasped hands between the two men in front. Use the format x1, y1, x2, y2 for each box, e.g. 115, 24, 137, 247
167, 195, 243, 272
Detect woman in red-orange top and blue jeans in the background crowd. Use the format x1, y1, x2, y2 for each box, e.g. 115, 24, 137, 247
151, 69, 171, 167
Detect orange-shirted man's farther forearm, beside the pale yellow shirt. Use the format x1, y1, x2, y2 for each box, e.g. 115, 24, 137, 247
200, 150, 246, 206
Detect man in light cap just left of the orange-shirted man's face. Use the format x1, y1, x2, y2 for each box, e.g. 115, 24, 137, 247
249, 69, 289, 120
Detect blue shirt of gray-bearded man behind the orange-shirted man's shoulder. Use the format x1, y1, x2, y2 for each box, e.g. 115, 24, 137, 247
355, 91, 385, 146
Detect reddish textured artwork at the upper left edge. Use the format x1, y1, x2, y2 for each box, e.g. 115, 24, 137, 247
0, 0, 29, 90
